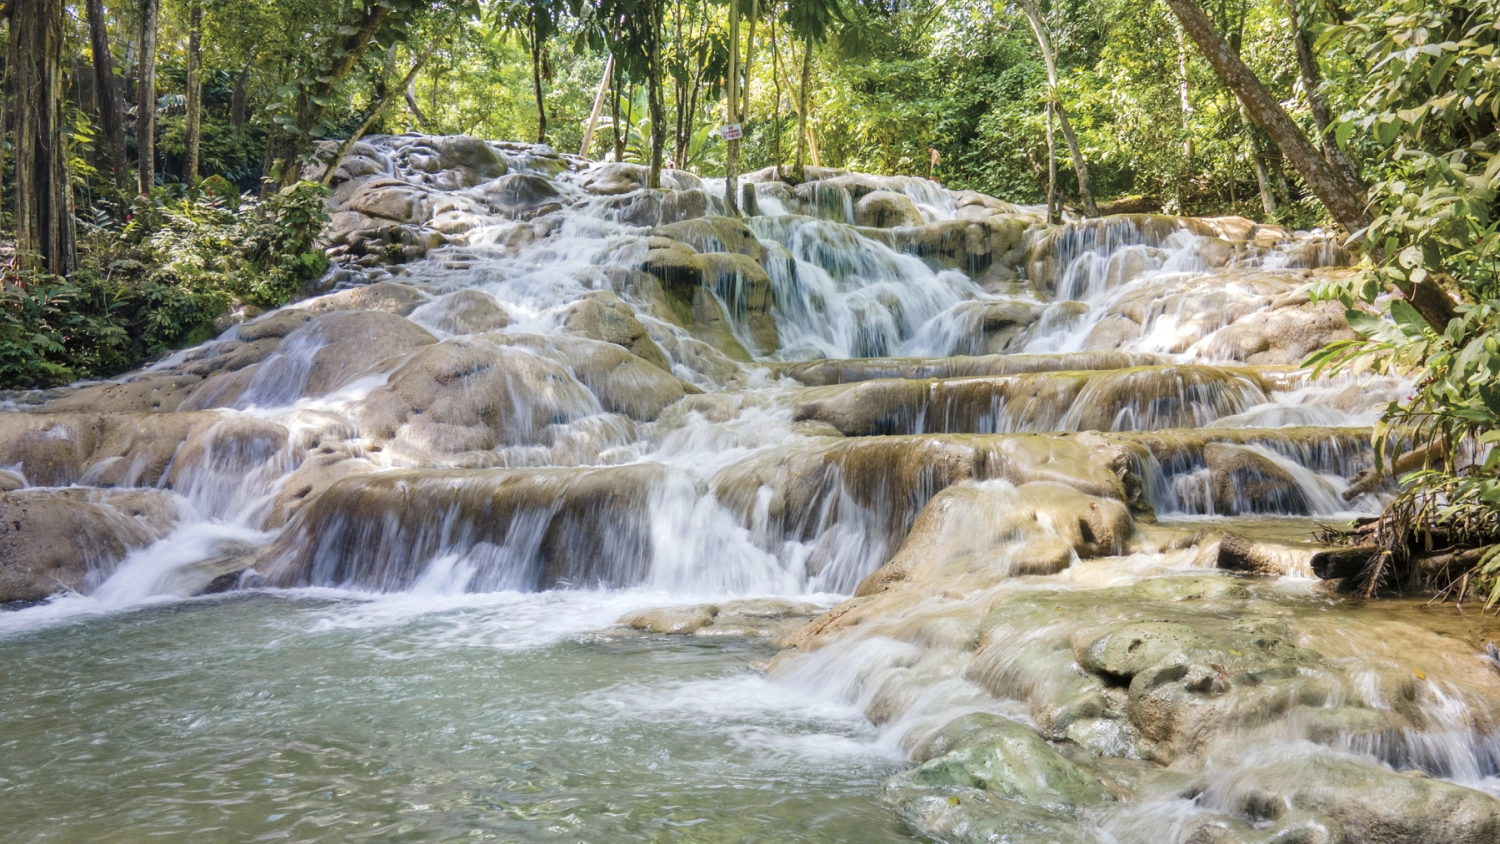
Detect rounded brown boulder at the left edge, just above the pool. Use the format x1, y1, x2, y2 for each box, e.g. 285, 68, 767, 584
0, 489, 177, 603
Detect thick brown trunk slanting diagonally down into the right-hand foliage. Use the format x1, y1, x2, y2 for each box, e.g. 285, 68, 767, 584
1167, 0, 1370, 231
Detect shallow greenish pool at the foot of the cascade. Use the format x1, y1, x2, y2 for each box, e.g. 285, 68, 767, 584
0, 591, 917, 843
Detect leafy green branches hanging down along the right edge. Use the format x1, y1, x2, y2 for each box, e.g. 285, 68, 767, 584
1310, 0, 1500, 603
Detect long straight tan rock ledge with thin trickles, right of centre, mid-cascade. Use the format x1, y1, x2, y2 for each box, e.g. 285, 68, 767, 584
794, 364, 1305, 436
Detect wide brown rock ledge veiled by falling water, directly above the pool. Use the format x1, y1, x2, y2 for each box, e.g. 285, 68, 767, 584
266, 465, 662, 592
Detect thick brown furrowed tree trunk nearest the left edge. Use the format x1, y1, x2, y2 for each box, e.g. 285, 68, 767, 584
6, 0, 75, 276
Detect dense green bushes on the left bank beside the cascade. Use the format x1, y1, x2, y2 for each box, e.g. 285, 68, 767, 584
0, 177, 327, 387
